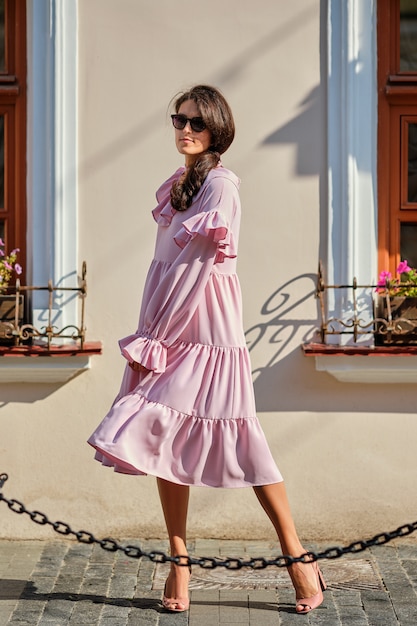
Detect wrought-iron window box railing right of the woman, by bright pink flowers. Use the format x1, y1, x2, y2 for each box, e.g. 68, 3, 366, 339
316, 262, 417, 345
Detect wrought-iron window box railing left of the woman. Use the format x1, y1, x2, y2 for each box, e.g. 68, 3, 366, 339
0, 261, 87, 350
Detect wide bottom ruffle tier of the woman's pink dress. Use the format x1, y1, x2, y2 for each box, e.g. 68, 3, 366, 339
88, 393, 283, 488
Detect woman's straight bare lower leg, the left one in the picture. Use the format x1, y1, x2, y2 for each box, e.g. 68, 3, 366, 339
158, 478, 190, 598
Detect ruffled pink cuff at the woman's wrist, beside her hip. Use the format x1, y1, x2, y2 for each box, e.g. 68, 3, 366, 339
119, 333, 167, 374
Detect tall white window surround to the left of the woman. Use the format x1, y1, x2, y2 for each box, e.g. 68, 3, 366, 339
27, 0, 79, 312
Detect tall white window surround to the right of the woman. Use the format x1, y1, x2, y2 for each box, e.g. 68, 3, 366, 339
326, 0, 378, 326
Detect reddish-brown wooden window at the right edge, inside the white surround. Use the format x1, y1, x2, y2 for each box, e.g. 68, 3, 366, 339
377, 0, 417, 274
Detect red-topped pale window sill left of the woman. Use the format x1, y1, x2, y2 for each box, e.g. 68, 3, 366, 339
0, 341, 102, 384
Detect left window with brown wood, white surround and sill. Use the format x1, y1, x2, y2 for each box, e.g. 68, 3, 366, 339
0, 0, 101, 383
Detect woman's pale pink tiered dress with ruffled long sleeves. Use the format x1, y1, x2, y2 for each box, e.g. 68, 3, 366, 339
88, 165, 282, 487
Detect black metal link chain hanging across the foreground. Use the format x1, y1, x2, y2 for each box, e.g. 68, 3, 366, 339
0, 474, 417, 570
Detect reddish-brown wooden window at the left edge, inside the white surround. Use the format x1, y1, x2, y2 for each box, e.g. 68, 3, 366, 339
0, 0, 26, 280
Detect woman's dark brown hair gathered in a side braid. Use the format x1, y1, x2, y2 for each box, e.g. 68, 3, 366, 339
171, 85, 235, 211
